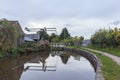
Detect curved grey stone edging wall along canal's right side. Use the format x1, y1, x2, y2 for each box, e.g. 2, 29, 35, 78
64, 48, 105, 80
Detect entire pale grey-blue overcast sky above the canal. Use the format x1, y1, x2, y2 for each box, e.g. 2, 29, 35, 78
0, 0, 120, 39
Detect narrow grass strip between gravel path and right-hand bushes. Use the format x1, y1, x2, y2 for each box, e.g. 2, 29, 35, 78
89, 46, 120, 57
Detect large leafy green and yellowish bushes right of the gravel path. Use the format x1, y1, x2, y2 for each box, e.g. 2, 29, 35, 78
91, 28, 120, 47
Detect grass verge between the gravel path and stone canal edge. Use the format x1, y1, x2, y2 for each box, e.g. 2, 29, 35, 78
69, 47, 120, 80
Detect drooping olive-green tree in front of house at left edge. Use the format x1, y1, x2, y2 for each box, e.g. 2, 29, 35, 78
0, 19, 22, 51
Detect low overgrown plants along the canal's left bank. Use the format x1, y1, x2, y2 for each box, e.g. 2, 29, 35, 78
0, 42, 64, 59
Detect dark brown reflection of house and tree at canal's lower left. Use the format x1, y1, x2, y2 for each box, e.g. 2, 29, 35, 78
0, 59, 24, 80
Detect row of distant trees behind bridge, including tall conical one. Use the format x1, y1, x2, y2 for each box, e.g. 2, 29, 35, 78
48, 28, 84, 45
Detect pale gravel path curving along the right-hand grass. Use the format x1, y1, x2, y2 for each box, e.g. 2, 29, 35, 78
84, 48, 120, 65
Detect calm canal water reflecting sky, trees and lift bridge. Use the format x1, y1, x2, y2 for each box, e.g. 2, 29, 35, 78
0, 51, 95, 80
